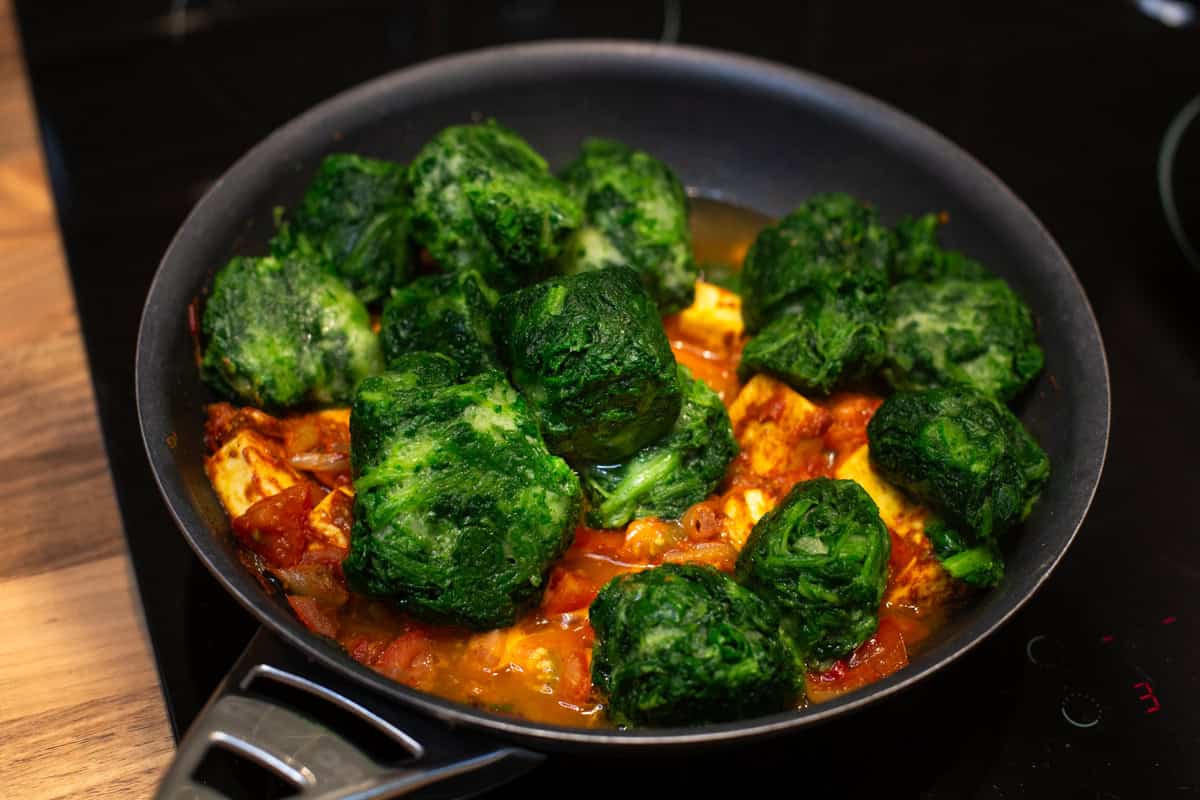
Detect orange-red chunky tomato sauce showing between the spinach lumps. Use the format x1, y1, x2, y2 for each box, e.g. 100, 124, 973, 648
205, 204, 946, 727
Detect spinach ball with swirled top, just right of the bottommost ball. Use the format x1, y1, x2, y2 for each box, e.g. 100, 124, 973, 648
737, 477, 892, 664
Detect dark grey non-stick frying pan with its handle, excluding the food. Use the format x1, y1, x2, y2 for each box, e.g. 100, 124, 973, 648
137, 41, 1109, 798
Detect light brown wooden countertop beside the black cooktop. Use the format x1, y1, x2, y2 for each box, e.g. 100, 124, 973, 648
0, 0, 174, 800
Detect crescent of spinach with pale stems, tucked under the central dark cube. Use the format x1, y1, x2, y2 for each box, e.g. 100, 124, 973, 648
580, 365, 738, 528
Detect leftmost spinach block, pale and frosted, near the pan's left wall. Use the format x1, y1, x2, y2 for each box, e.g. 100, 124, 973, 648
200, 255, 383, 409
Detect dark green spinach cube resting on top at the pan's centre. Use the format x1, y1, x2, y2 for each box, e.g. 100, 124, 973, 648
493, 266, 683, 464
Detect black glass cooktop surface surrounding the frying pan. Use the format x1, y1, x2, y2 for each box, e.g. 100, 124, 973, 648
17, 0, 1200, 798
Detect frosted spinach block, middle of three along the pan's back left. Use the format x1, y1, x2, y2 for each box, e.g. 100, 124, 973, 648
409, 121, 583, 291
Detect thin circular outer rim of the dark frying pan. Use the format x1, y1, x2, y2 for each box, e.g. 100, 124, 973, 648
134, 40, 1111, 750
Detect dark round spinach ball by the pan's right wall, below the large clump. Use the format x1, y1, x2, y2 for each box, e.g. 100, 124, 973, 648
866, 386, 1050, 541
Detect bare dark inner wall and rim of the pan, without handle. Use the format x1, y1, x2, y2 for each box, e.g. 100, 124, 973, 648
137, 42, 1109, 748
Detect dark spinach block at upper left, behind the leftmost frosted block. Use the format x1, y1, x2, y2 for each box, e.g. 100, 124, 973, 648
271, 154, 413, 303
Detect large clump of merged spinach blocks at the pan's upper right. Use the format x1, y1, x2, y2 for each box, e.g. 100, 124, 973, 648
739, 194, 1043, 401
